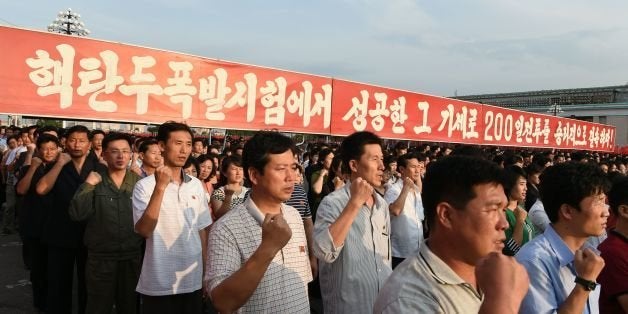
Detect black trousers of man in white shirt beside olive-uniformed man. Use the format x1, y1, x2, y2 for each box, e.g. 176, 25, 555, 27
142, 290, 203, 314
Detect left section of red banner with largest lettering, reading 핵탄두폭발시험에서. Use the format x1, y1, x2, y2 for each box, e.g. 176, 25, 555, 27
0, 27, 332, 134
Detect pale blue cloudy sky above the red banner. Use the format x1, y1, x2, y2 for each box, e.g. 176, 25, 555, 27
0, 0, 628, 97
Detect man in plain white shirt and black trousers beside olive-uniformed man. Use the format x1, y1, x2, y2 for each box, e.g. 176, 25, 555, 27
133, 122, 212, 314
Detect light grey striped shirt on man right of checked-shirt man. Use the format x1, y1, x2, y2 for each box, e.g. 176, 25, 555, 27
314, 183, 392, 313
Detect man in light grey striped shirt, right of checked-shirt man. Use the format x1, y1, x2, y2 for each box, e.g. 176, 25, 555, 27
314, 132, 392, 313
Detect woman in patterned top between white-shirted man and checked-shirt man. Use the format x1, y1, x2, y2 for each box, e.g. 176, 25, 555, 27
210, 155, 249, 219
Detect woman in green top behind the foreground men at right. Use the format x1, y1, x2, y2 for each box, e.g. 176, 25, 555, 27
503, 165, 535, 256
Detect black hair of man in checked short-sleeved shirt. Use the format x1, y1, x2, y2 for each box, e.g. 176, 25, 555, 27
243, 131, 297, 181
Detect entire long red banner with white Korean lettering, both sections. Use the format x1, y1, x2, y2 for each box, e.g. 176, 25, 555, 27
0, 26, 615, 151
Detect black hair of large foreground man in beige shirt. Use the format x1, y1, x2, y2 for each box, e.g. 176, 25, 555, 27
421, 156, 503, 227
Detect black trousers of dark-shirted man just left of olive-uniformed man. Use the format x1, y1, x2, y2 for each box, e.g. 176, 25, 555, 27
46, 245, 87, 314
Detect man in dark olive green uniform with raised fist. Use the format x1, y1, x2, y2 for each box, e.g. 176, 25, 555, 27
69, 133, 142, 313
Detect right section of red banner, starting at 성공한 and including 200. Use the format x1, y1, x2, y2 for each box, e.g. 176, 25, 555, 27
331, 80, 615, 151
